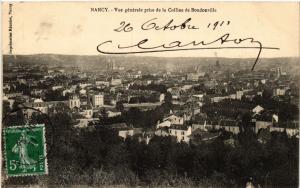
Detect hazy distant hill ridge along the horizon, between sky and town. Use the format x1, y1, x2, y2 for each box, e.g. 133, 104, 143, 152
3, 54, 300, 71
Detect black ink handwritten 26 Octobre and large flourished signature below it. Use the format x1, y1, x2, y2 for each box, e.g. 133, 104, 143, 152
97, 18, 280, 70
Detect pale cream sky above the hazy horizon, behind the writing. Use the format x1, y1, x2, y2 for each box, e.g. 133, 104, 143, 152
2, 2, 300, 58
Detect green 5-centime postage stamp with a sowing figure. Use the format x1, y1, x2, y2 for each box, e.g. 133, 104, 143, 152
4, 124, 48, 176
